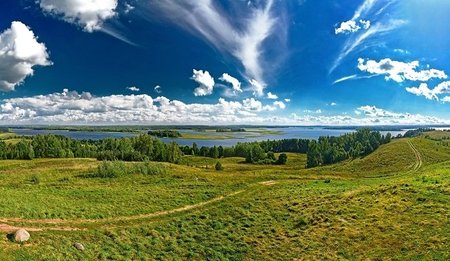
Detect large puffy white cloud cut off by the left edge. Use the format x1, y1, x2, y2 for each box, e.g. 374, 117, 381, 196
0, 21, 52, 91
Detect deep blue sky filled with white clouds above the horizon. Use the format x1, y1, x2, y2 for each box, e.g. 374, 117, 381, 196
0, 0, 450, 125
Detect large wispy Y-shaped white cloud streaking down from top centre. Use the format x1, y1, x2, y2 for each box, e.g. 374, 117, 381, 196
146, 0, 286, 88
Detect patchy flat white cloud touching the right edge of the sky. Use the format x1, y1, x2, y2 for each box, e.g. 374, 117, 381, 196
358, 58, 447, 82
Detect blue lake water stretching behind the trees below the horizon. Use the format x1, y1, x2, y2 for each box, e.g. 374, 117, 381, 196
12, 127, 406, 147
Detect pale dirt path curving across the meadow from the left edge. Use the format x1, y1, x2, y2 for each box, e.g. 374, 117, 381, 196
0, 180, 276, 233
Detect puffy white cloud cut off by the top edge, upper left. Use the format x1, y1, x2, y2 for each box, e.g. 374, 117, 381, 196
38, 0, 117, 32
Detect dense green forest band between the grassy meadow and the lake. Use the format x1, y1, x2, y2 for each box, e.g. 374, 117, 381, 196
0, 129, 391, 167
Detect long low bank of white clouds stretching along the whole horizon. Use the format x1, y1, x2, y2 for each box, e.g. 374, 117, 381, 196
0, 89, 444, 125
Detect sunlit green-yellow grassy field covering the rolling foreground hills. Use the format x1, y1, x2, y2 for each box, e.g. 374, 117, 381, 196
0, 134, 450, 260
